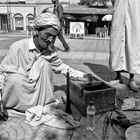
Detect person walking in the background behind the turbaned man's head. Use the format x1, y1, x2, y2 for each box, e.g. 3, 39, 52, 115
52, 0, 70, 52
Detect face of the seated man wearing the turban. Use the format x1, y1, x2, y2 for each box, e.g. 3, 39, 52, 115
38, 28, 56, 49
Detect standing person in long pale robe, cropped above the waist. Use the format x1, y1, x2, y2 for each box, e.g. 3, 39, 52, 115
110, 0, 140, 92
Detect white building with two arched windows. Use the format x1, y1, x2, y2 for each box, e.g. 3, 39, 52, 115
0, 0, 35, 31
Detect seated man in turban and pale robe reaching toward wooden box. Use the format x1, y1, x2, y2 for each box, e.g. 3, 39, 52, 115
0, 13, 91, 117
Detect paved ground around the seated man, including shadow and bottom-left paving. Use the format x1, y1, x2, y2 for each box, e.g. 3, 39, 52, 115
0, 33, 140, 140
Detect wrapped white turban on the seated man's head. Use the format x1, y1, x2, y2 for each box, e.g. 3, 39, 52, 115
34, 12, 60, 32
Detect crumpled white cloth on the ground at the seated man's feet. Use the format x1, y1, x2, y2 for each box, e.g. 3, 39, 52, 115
25, 100, 80, 129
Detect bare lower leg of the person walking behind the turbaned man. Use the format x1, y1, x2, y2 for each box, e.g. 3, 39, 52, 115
58, 29, 70, 51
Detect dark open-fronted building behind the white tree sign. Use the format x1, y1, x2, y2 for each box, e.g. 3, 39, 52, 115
64, 0, 113, 35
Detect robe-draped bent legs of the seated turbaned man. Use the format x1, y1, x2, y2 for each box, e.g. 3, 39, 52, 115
2, 60, 55, 112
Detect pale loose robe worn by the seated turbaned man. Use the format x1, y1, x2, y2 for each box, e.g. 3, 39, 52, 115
0, 39, 84, 112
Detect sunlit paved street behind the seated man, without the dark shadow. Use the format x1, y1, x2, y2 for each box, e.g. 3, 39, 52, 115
0, 32, 109, 80
